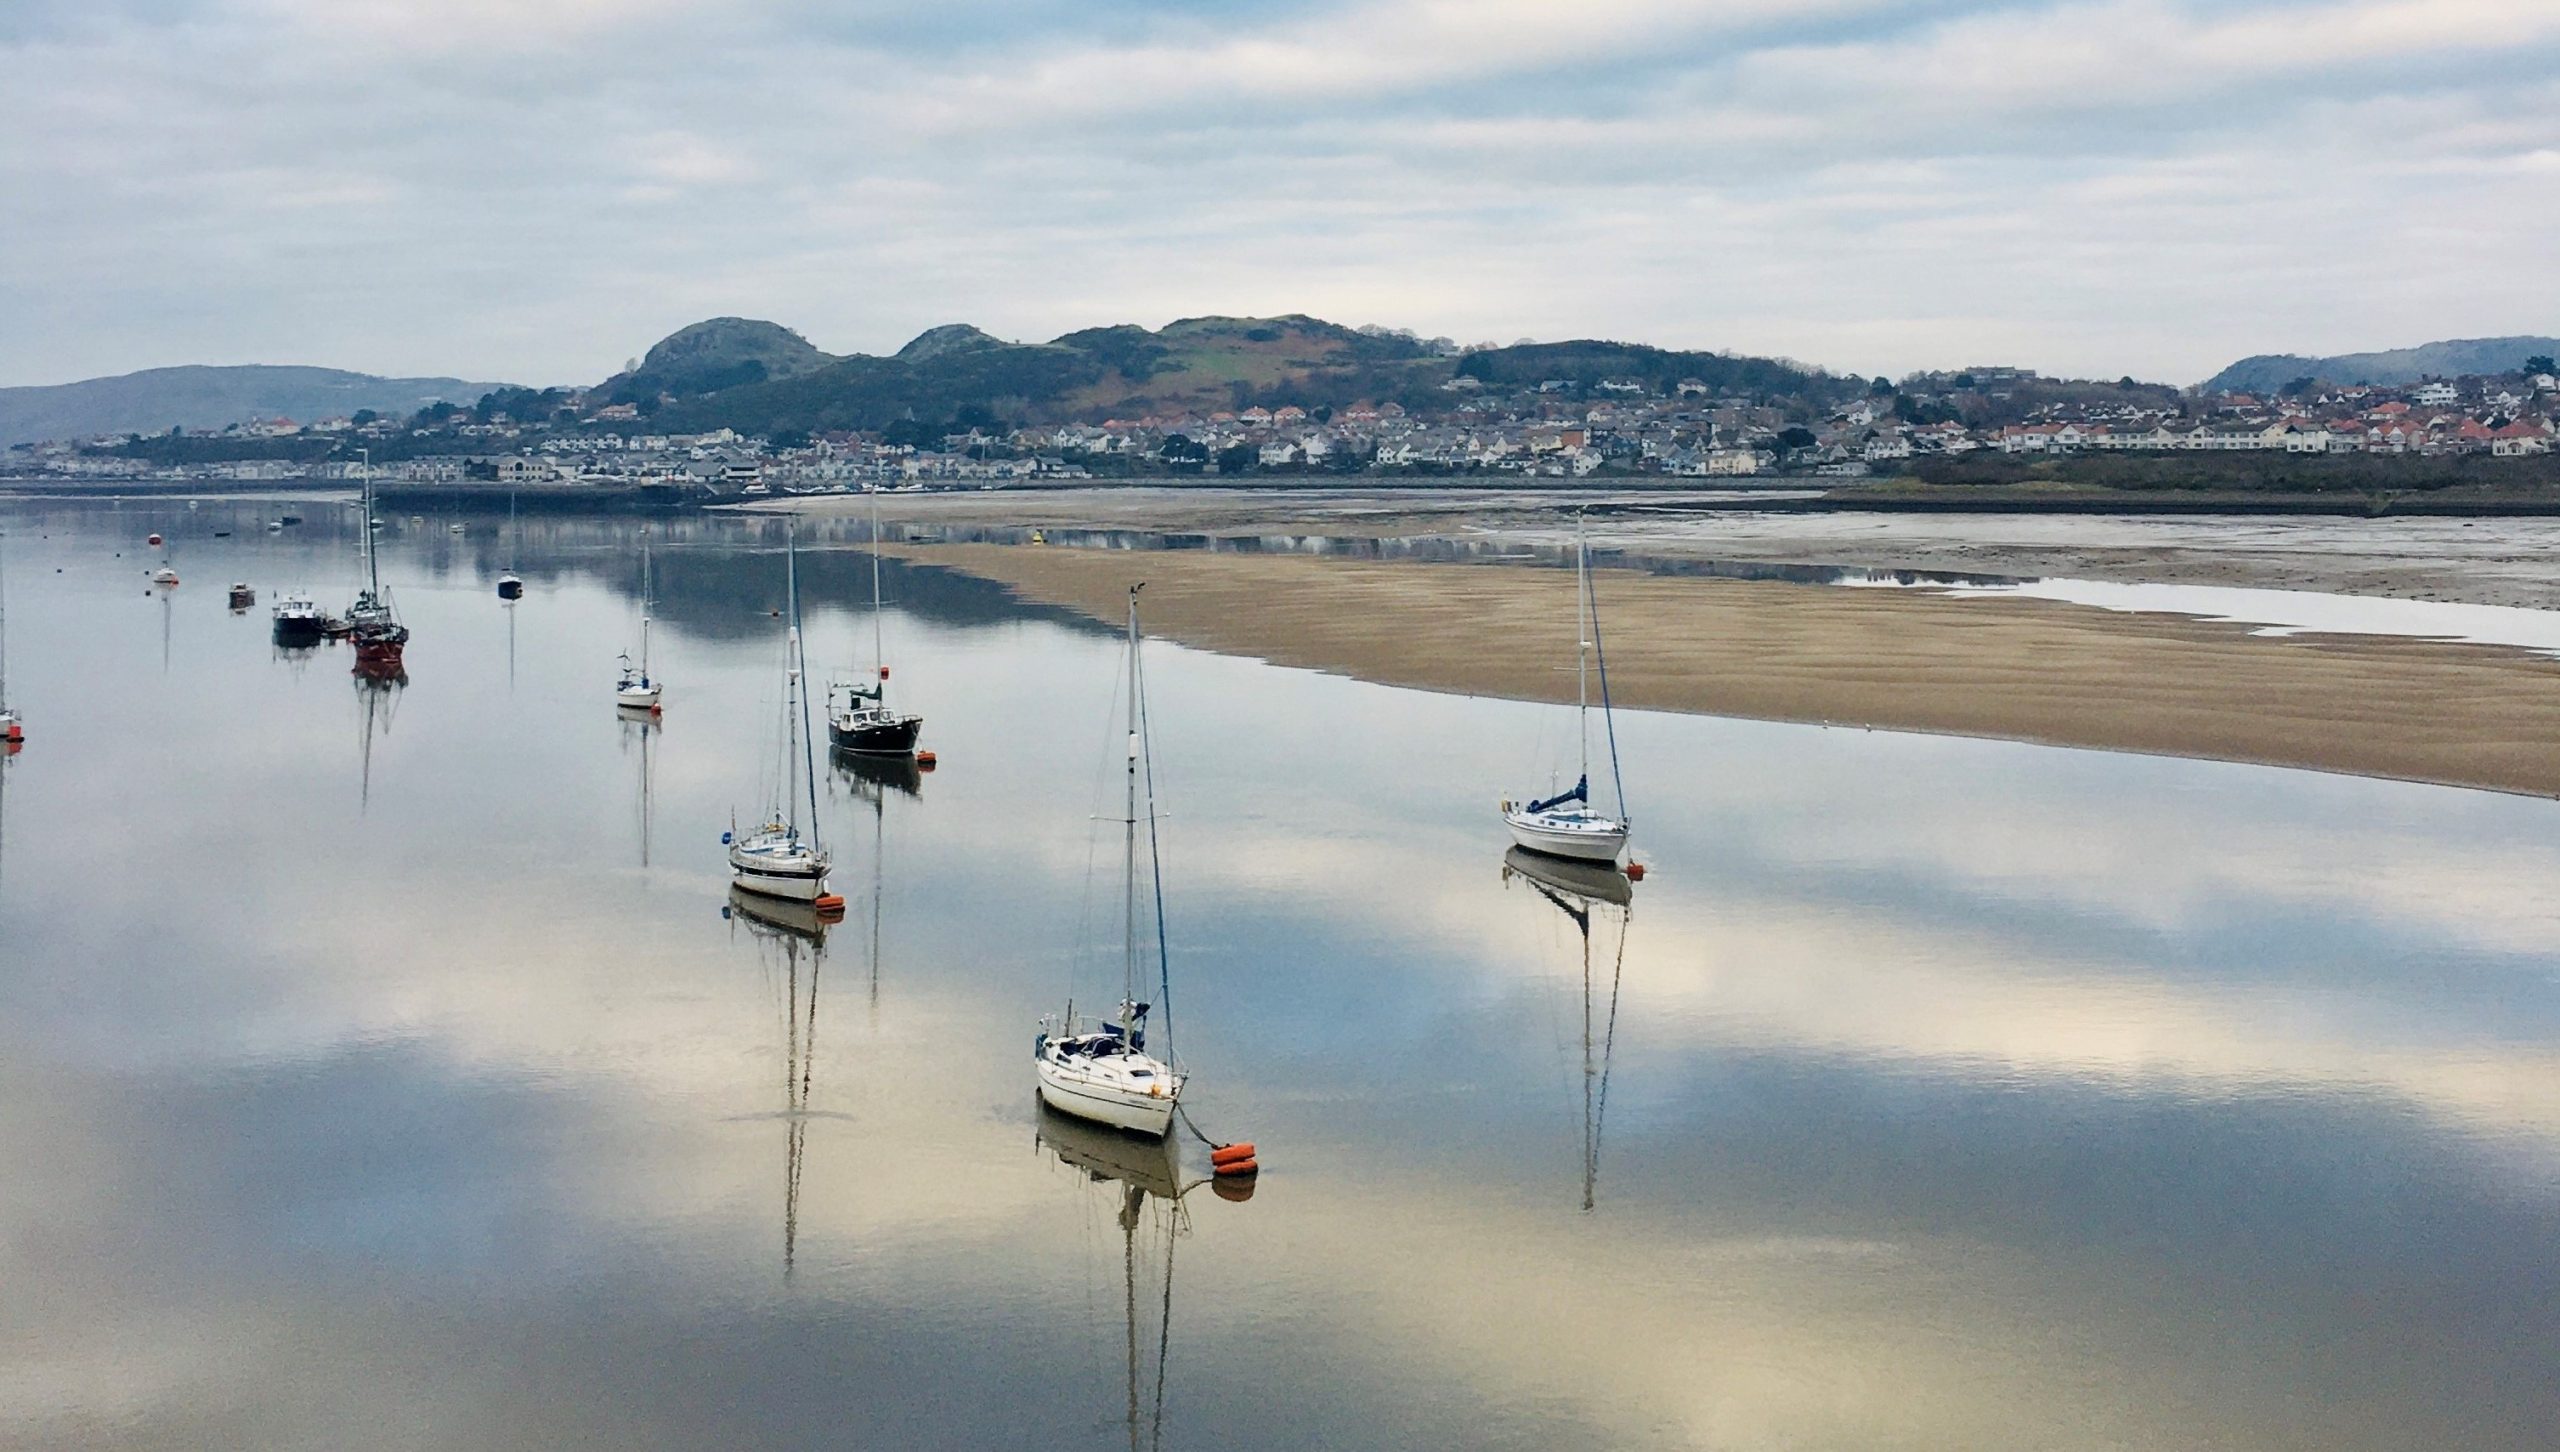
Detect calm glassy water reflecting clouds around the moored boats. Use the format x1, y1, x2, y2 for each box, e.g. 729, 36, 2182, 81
0, 502, 2560, 1449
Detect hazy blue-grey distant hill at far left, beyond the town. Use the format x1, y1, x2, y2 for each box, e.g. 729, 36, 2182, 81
0, 364, 507, 448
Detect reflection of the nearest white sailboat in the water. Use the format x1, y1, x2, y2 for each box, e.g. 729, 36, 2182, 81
1037, 1104, 1228, 1452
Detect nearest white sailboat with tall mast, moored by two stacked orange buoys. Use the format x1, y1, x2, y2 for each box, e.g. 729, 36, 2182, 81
1032, 584, 1183, 1137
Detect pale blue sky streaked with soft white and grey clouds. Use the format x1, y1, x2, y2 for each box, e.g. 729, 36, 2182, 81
0, 0, 2560, 384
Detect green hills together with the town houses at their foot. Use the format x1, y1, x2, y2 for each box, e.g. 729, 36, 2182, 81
5, 318, 2560, 494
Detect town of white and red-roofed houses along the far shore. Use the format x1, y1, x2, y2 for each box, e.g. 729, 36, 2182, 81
0, 359, 2560, 497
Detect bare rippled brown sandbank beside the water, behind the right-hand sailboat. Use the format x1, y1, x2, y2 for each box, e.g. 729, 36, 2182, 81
896, 545, 2560, 796
